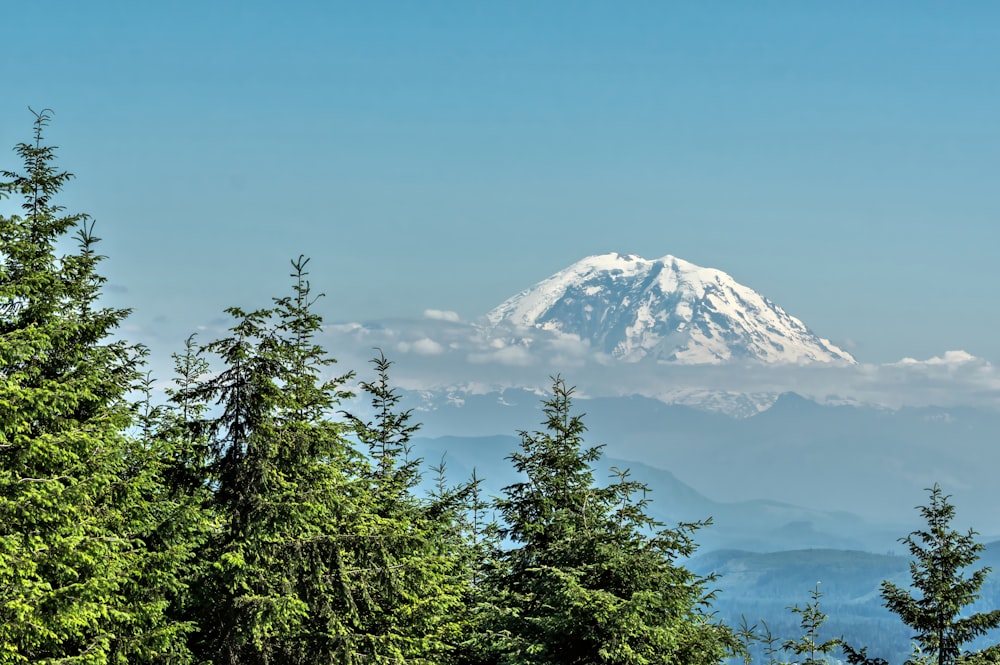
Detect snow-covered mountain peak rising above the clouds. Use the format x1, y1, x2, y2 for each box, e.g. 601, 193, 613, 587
487, 254, 855, 365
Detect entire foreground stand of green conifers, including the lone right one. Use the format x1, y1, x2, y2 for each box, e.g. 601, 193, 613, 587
0, 111, 1000, 665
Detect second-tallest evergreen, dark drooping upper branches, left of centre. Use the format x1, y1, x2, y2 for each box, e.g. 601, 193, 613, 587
184, 258, 358, 663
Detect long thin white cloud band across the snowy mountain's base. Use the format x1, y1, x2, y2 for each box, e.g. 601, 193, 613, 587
316, 318, 1000, 409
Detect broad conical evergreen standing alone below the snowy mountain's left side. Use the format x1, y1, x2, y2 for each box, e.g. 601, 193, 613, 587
482, 378, 739, 665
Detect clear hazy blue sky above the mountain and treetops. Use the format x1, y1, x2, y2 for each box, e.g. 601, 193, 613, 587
0, 0, 1000, 363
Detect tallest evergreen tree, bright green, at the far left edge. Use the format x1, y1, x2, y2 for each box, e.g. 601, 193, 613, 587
0, 111, 183, 663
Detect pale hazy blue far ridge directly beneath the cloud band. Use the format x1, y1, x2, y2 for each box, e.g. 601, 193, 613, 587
396, 389, 1000, 536
